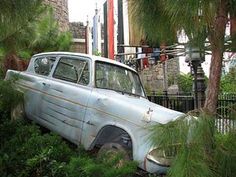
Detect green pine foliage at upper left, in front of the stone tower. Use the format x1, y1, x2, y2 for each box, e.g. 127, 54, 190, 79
0, 0, 72, 69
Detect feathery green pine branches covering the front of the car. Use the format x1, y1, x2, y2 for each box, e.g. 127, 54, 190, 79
150, 113, 219, 177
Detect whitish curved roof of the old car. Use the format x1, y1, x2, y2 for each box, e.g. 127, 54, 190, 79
33, 52, 136, 72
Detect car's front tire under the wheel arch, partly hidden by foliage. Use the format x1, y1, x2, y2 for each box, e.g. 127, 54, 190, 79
97, 143, 131, 168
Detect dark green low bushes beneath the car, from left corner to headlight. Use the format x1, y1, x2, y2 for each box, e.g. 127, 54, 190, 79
0, 121, 137, 177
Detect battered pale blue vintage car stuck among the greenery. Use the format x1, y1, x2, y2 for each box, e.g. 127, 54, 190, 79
6, 52, 183, 173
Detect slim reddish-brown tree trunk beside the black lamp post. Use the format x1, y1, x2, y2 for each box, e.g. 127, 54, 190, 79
204, 0, 228, 114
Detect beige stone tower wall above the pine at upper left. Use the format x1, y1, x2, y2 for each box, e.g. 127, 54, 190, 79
44, 0, 69, 31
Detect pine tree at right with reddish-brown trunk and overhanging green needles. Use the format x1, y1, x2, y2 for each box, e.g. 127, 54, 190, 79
129, 0, 236, 113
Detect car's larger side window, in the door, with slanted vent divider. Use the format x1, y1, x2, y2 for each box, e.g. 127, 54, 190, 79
53, 57, 89, 85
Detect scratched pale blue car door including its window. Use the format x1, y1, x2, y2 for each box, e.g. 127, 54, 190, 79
38, 55, 91, 144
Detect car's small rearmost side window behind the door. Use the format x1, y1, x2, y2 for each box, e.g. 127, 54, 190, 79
34, 57, 56, 76
